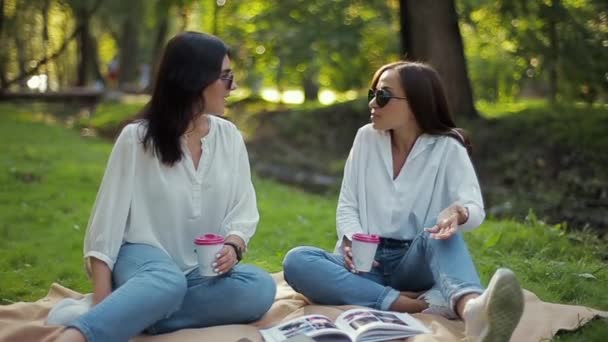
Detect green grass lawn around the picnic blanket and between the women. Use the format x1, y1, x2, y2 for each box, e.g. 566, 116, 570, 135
0, 104, 608, 341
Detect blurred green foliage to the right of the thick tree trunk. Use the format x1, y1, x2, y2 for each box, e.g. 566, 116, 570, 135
459, 0, 608, 102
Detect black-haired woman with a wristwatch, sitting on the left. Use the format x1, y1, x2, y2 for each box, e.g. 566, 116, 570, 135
58, 32, 275, 341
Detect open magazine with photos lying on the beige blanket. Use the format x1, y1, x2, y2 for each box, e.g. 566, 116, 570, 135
260, 309, 431, 342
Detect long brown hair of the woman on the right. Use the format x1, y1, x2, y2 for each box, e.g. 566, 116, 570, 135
371, 61, 473, 155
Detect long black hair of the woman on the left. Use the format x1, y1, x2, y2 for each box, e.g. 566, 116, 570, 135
140, 32, 229, 166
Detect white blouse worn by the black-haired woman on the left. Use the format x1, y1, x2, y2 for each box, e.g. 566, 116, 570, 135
84, 115, 259, 272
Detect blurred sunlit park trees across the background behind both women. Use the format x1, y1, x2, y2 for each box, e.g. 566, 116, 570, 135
0, 0, 608, 109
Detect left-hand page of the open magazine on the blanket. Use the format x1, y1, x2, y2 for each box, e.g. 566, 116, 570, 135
260, 315, 351, 342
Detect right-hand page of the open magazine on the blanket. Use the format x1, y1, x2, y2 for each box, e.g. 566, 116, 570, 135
336, 309, 430, 341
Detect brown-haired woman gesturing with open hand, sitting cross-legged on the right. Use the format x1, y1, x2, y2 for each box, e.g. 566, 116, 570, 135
283, 62, 523, 341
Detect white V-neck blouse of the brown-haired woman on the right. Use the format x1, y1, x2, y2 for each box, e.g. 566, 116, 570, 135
336, 124, 485, 251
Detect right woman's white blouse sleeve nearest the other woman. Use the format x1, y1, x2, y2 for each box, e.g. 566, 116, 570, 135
336, 129, 362, 241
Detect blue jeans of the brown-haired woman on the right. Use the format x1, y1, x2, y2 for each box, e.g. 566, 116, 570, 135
283, 232, 483, 310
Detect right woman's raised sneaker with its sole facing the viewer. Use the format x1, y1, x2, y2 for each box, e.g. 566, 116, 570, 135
463, 268, 524, 342
